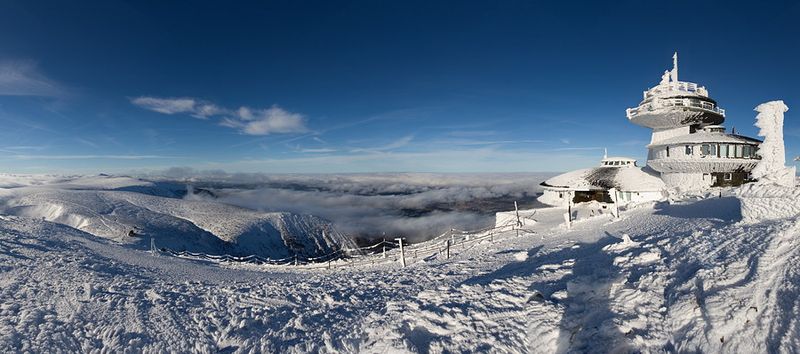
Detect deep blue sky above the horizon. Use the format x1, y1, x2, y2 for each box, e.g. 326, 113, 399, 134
0, 0, 800, 173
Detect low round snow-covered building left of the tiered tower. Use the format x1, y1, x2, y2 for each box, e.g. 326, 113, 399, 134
539, 157, 666, 206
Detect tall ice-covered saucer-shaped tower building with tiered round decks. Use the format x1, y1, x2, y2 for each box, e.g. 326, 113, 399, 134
626, 53, 761, 190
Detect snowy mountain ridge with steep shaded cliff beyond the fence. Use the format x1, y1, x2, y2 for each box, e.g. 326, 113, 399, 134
0, 176, 353, 258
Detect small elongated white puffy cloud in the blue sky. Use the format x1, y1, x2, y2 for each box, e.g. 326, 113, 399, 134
131, 96, 308, 135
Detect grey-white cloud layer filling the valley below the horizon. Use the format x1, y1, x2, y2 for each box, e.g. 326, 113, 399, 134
144, 168, 550, 241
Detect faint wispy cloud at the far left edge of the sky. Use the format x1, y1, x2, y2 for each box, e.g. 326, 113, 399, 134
0, 61, 64, 97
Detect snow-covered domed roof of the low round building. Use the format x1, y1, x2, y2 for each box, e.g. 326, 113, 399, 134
541, 166, 666, 192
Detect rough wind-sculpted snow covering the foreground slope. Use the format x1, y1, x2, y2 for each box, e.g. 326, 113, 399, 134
0, 184, 800, 353
